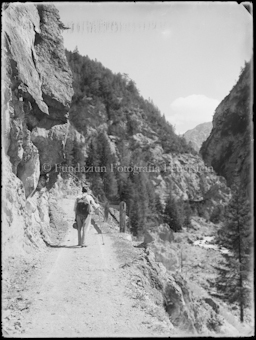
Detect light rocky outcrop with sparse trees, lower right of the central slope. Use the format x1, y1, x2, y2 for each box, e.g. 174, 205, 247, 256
128, 134, 230, 214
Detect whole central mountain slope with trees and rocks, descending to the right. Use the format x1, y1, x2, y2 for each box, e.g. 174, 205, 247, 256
66, 50, 232, 235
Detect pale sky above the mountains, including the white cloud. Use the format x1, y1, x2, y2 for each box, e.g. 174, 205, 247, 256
55, 2, 252, 134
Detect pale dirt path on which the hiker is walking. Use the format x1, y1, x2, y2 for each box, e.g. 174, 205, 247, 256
17, 199, 170, 337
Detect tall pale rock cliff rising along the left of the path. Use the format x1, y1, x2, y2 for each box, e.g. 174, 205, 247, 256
2, 3, 73, 255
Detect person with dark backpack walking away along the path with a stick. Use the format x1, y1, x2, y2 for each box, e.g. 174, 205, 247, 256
74, 187, 99, 247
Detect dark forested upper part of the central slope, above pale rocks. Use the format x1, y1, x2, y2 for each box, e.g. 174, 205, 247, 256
66, 51, 194, 153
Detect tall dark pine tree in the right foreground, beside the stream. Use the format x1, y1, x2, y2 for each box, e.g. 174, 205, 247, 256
216, 187, 253, 322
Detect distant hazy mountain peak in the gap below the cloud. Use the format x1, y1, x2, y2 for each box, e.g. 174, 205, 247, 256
183, 122, 212, 152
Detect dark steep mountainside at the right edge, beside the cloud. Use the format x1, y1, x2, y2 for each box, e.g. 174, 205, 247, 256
200, 63, 252, 191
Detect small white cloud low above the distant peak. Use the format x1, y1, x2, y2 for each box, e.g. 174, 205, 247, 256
166, 94, 219, 134
